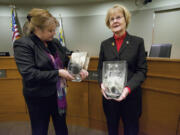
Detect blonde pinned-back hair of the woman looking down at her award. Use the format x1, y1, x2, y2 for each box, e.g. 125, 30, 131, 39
27, 8, 59, 34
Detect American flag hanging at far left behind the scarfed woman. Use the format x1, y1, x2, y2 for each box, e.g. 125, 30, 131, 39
12, 8, 20, 42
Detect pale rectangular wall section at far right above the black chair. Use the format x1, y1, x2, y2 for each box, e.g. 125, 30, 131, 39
153, 8, 180, 58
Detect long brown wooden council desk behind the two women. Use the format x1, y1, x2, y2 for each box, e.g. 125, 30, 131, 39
0, 57, 180, 135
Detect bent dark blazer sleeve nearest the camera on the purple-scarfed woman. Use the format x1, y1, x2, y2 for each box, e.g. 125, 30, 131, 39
13, 39, 58, 83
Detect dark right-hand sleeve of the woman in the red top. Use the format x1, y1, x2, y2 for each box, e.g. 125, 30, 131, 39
127, 39, 147, 91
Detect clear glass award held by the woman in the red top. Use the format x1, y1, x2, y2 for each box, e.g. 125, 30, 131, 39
102, 61, 127, 99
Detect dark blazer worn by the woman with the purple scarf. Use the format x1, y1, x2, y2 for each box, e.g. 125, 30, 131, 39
13, 34, 69, 97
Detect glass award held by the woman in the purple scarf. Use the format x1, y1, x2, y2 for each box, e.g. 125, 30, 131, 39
68, 52, 90, 82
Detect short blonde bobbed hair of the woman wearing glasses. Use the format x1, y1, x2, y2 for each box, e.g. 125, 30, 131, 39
105, 4, 131, 28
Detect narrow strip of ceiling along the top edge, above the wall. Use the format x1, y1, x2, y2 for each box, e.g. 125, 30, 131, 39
0, 0, 117, 5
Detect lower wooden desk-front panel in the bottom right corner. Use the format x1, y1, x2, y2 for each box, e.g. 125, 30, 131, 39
140, 89, 180, 135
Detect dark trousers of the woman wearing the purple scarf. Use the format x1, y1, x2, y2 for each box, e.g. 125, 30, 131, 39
25, 94, 68, 135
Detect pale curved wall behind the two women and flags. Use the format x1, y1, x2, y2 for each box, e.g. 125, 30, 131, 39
0, 0, 180, 58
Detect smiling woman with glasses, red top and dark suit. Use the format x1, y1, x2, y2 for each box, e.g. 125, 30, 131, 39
98, 5, 147, 135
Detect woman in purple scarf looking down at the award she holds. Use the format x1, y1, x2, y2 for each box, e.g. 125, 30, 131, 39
14, 8, 88, 135
